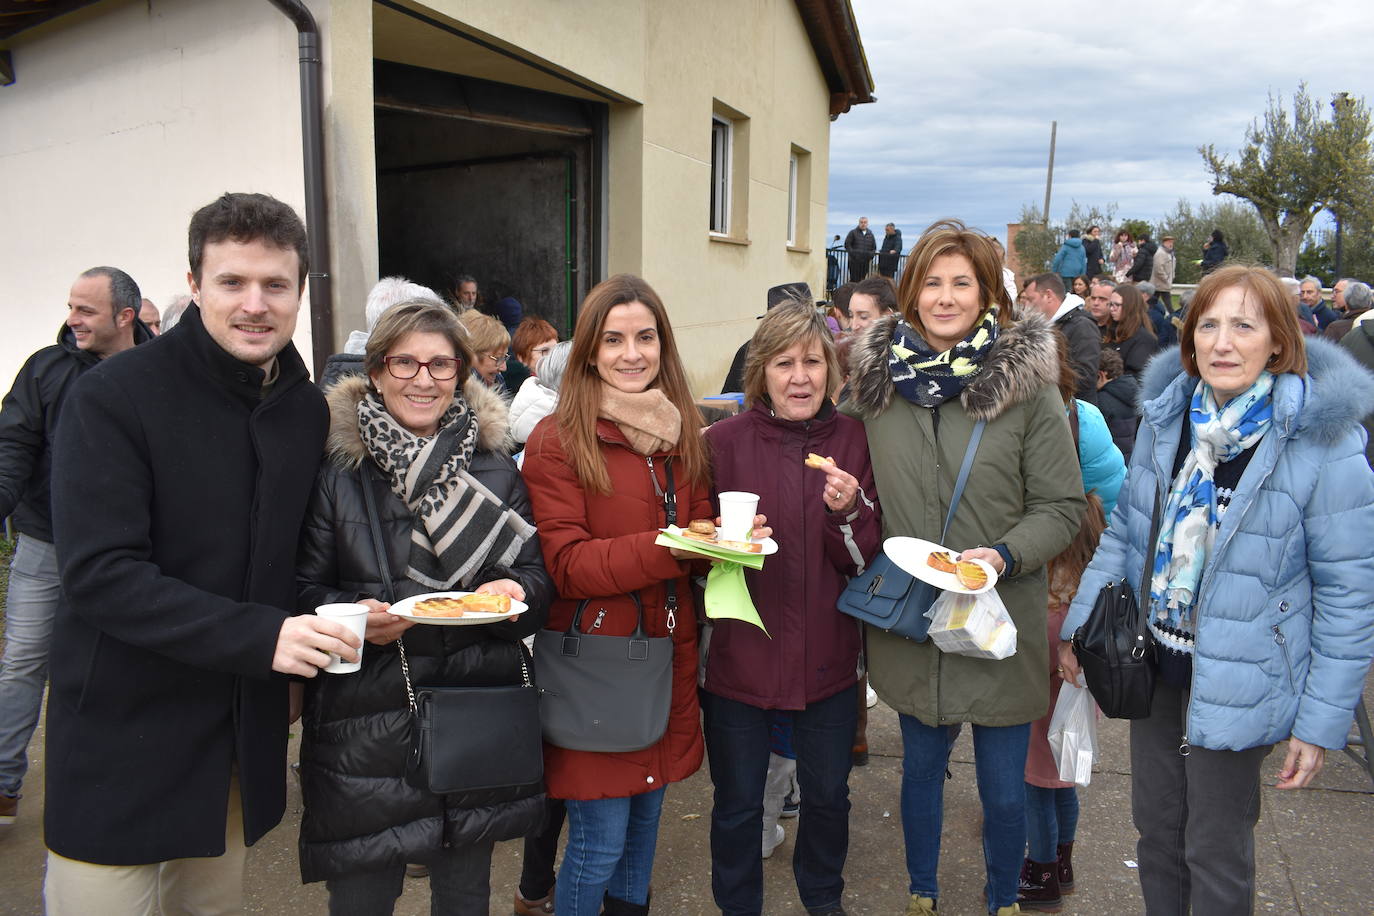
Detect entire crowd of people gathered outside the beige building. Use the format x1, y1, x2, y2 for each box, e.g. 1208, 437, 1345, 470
0, 194, 1374, 916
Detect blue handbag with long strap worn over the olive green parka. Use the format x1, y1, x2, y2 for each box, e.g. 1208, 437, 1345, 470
835, 420, 988, 643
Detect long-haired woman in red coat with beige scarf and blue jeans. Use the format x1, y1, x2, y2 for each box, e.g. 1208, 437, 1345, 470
523, 275, 710, 916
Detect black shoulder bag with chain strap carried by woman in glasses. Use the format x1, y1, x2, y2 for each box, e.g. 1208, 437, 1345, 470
359, 464, 544, 801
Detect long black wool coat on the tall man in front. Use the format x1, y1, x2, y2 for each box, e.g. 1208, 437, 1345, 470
44, 305, 327, 865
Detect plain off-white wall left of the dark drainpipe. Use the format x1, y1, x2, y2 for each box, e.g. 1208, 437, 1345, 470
0, 0, 324, 389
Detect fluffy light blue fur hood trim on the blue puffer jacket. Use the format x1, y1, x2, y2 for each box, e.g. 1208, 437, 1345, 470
1139, 336, 1374, 442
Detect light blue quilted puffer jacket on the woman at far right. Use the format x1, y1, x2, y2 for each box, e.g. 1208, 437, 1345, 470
1062, 338, 1374, 750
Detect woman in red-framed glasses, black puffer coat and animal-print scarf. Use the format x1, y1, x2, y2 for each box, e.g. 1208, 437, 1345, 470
297, 301, 552, 916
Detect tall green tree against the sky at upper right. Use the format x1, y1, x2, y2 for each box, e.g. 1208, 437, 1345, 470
1198, 84, 1374, 276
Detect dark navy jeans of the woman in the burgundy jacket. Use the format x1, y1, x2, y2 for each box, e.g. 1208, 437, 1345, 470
701, 687, 859, 916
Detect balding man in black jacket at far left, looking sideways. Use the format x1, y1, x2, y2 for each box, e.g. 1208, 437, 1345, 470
0, 266, 153, 824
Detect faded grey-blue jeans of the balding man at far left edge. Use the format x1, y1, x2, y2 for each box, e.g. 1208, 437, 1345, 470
0, 534, 62, 795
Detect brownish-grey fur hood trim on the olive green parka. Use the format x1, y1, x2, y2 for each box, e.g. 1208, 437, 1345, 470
849, 312, 1059, 420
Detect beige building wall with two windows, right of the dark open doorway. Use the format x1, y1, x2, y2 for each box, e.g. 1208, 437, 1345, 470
392, 0, 830, 394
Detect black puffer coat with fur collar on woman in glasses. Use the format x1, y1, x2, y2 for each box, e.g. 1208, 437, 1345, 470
298, 376, 554, 882
